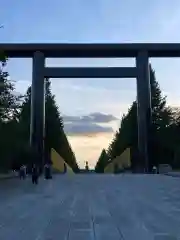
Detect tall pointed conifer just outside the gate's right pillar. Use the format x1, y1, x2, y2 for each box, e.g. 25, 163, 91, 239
149, 68, 173, 167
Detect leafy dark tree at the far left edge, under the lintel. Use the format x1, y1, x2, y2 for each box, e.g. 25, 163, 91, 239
0, 58, 19, 170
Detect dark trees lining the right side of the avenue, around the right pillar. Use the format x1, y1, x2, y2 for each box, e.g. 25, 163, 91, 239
95, 66, 180, 172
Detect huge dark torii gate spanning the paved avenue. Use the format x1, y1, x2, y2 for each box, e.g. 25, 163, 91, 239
0, 43, 180, 172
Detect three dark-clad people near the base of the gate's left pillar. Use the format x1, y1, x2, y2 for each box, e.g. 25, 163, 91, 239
19, 164, 52, 184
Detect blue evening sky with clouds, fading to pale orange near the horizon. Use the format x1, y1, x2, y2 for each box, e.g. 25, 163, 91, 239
0, 0, 180, 167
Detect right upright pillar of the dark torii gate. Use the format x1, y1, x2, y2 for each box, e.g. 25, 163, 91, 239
136, 51, 152, 172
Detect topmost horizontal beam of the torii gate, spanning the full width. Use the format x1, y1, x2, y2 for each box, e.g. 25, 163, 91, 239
0, 43, 180, 58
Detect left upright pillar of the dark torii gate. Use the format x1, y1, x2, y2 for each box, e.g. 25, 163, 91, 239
30, 51, 45, 167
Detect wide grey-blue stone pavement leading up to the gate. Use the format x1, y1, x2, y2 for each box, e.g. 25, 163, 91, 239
0, 174, 180, 240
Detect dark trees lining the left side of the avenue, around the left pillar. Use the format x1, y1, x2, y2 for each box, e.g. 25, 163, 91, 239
0, 58, 79, 172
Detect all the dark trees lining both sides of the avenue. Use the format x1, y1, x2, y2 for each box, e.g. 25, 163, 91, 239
0, 58, 180, 173
